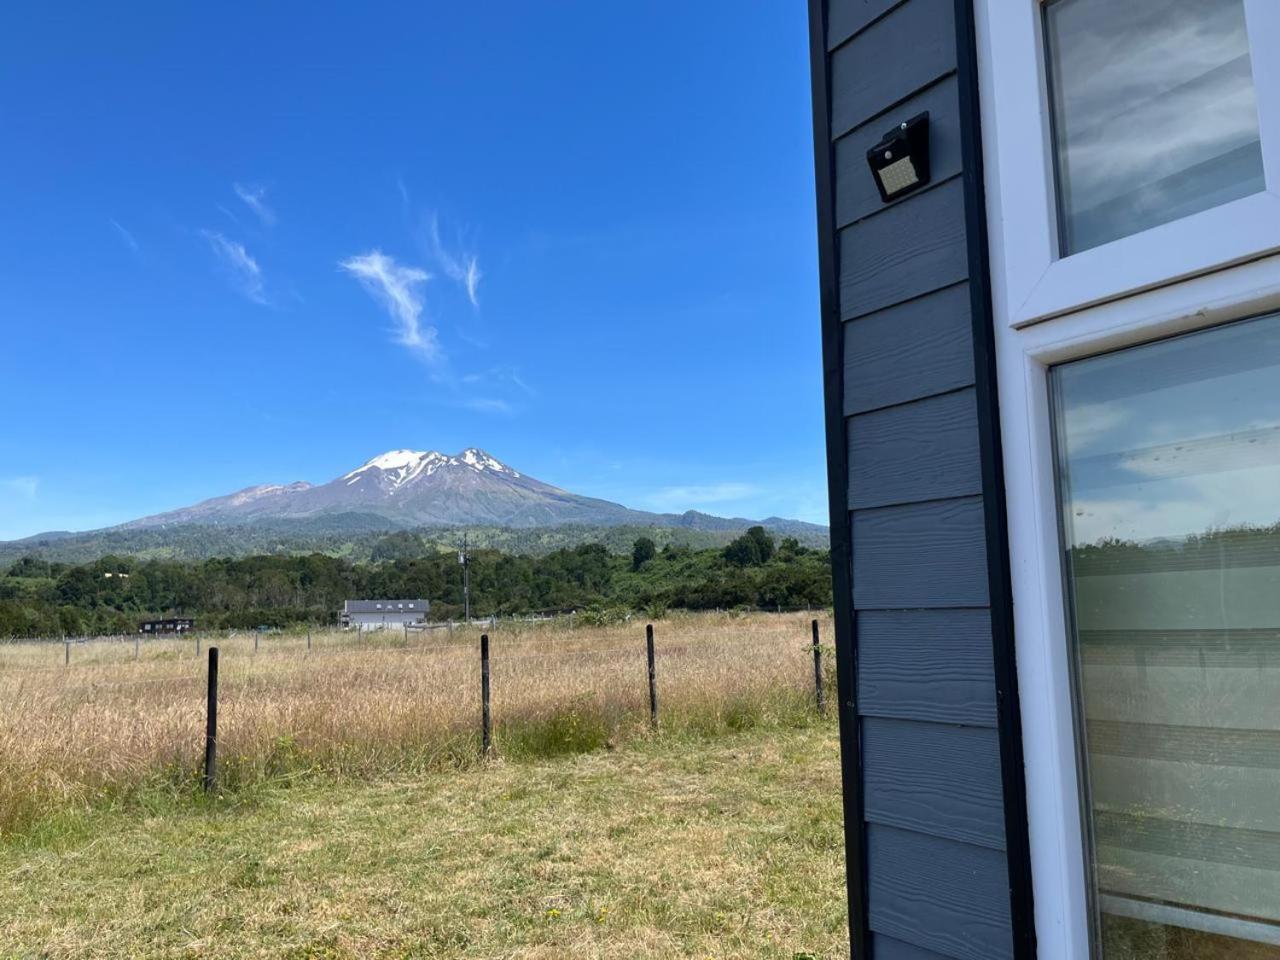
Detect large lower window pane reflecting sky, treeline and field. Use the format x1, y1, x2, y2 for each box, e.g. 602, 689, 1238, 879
1051, 316, 1280, 960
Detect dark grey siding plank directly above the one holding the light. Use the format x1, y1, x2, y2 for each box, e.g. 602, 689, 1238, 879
831, 0, 956, 138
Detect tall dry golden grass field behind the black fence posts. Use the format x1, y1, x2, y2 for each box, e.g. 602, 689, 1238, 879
0, 614, 829, 837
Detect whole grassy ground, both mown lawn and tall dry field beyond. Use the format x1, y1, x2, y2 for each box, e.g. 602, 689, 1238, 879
0, 614, 847, 960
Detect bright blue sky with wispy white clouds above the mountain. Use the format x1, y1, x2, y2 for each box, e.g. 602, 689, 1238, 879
0, 3, 826, 539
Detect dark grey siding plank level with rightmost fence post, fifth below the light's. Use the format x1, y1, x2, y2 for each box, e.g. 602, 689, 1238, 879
858, 609, 996, 727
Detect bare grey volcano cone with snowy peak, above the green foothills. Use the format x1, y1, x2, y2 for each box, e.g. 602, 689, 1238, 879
124, 447, 655, 527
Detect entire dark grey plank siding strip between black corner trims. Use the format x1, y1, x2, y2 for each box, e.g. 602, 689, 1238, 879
822, 0, 1014, 960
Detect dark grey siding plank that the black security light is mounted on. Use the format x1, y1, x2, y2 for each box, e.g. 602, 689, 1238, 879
836, 74, 964, 227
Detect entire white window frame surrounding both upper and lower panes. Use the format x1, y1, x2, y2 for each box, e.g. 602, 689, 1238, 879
975, 0, 1280, 960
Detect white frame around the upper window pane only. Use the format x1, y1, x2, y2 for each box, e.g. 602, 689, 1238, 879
979, 0, 1280, 326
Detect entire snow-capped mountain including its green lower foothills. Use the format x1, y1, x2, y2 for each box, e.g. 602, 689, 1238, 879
0, 448, 828, 563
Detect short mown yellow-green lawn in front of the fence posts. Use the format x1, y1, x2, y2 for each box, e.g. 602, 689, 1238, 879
0, 722, 847, 960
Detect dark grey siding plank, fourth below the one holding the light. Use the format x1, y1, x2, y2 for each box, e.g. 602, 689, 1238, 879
851, 497, 989, 609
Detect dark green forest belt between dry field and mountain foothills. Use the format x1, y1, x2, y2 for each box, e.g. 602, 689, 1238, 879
0, 527, 831, 637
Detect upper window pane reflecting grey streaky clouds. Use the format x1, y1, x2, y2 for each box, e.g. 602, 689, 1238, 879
1044, 0, 1263, 256
